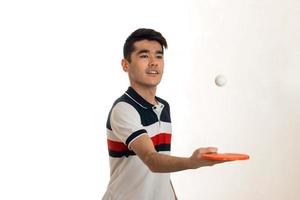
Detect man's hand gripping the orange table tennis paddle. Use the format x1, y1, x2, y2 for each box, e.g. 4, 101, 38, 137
189, 147, 225, 169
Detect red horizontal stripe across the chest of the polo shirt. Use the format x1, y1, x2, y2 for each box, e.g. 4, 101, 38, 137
107, 133, 172, 151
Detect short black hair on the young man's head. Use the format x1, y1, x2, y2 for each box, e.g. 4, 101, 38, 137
123, 28, 168, 62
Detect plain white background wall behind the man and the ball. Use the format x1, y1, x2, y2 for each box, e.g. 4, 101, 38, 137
0, 0, 300, 200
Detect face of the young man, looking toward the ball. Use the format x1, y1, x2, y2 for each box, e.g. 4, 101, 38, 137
122, 40, 164, 88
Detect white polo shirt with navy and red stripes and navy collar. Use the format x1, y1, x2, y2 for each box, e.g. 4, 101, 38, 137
103, 87, 175, 200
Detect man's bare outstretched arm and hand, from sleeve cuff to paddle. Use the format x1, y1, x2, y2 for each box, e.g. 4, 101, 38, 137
130, 134, 224, 173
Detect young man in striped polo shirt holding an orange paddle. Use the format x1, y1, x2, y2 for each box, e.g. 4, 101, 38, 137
103, 29, 227, 200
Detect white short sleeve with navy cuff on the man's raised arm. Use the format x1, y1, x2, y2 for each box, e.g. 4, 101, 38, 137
110, 102, 147, 146
